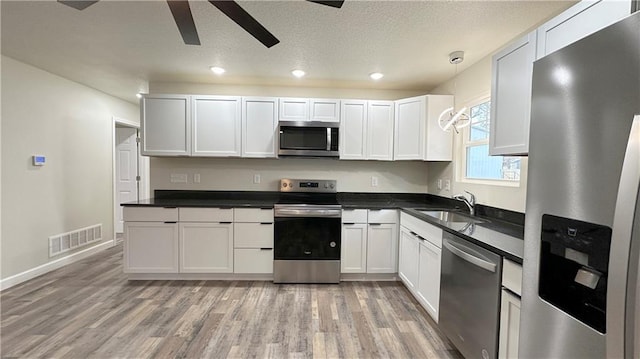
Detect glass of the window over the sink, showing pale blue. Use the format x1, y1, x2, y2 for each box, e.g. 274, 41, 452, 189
463, 100, 520, 181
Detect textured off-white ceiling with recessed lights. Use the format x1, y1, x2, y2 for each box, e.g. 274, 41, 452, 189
0, 0, 575, 102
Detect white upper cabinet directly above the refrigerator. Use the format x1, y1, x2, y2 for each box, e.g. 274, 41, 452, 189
537, 0, 631, 59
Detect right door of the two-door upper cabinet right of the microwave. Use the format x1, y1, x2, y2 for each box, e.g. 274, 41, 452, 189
366, 101, 394, 161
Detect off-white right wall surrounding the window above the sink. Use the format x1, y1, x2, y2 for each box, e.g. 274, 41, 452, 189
428, 56, 527, 212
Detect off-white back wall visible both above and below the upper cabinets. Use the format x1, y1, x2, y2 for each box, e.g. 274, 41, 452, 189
149, 82, 427, 193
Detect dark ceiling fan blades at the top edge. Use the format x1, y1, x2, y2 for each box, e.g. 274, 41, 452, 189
58, 0, 344, 48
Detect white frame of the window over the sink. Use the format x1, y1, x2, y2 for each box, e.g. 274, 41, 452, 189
456, 95, 522, 187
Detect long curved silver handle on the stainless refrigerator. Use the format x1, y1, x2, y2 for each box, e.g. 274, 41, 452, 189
607, 115, 640, 358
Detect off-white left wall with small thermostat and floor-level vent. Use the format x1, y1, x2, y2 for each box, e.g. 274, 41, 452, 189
0, 56, 139, 279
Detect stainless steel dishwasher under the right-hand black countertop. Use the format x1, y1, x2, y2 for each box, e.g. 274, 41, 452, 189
438, 232, 502, 359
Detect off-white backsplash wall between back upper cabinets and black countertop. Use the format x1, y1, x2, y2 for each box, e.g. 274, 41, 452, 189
151, 158, 427, 193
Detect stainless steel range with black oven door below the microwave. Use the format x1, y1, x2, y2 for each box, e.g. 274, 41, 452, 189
273, 179, 342, 283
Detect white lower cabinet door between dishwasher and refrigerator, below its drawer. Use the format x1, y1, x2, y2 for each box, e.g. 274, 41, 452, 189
498, 289, 520, 359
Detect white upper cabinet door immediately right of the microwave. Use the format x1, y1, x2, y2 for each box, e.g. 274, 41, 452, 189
340, 100, 368, 160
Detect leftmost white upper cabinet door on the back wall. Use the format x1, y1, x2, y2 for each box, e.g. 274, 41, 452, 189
140, 95, 191, 156
